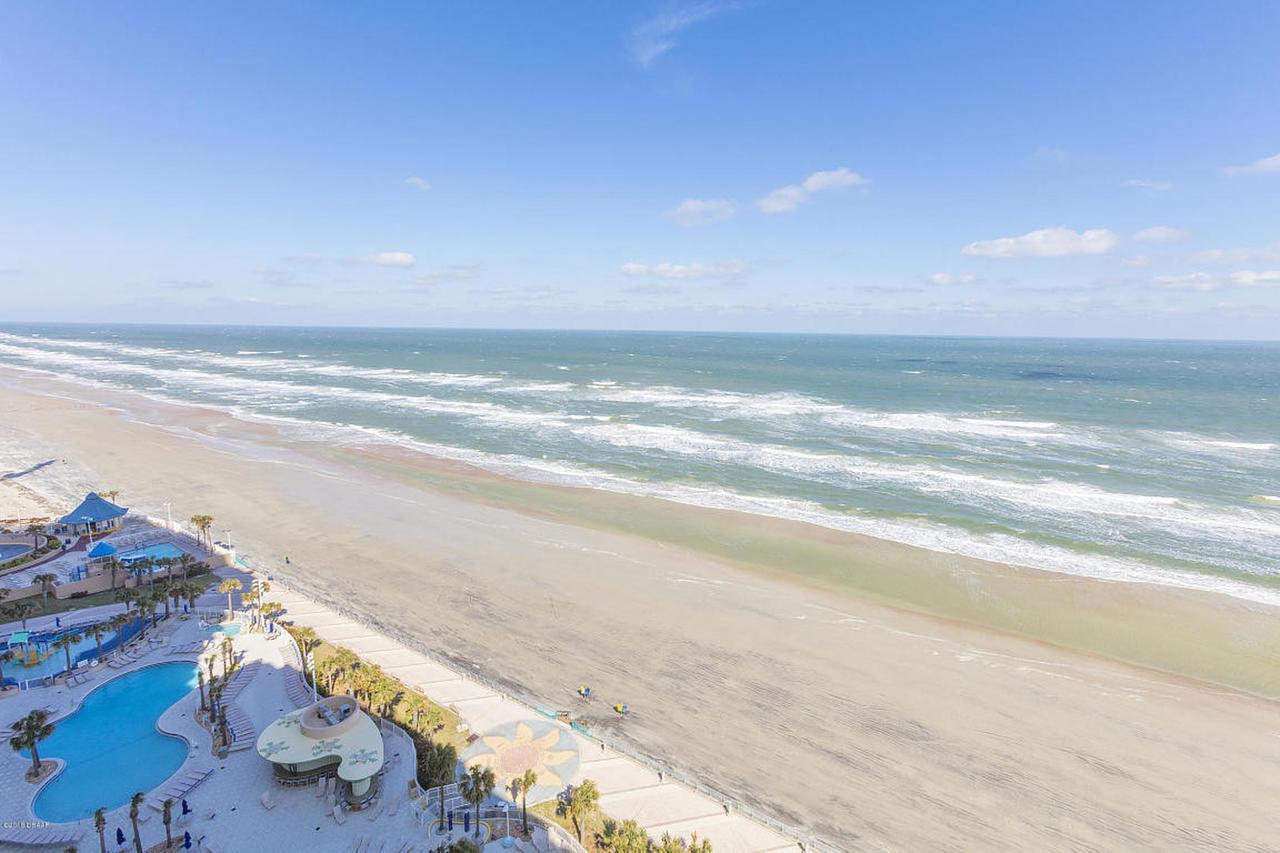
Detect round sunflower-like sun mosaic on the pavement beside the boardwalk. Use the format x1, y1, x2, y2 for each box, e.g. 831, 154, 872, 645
462, 720, 581, 804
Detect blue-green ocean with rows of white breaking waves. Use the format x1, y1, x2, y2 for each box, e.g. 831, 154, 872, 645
0, 325, 1280, 603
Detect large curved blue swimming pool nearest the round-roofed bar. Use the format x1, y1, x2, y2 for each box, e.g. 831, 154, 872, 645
24, 663, 196, 822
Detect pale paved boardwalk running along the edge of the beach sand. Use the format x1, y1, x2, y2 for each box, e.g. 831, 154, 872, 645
249, 569, 800, 853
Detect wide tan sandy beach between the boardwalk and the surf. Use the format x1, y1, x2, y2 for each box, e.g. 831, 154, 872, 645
0, 370, 1280, 850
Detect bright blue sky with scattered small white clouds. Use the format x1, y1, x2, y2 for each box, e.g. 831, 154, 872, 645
0, 0, 1280, 338
